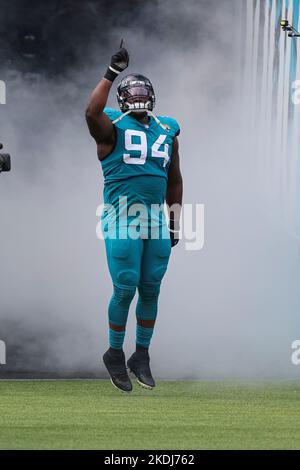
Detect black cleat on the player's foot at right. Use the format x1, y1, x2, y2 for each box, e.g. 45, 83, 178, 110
127, 346, 155, 390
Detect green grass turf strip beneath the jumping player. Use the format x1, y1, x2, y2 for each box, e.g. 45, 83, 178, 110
0, 380, 300, 450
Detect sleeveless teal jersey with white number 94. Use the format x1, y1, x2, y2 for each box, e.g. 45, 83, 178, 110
101, 108, 180, 232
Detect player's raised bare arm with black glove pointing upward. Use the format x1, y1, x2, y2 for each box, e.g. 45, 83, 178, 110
85, 48, 129, 144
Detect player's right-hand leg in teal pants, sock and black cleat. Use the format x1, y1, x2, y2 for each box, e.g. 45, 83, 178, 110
127, 235, 171, 388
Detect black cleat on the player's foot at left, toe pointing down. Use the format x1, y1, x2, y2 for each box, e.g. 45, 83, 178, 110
103, 348, 132, 392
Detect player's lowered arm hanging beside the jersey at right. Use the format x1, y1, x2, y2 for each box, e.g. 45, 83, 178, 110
166, 137, 183, 247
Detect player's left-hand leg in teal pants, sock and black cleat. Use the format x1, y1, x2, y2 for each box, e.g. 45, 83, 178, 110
103, 238, 143, 391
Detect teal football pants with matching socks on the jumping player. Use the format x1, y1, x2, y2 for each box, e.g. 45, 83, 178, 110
105, 238, 171, 349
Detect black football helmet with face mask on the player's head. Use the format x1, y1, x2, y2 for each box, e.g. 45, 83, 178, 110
117, 74, 155, 113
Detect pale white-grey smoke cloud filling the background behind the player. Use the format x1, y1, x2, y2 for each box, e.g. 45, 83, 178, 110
0, 0, 300, 378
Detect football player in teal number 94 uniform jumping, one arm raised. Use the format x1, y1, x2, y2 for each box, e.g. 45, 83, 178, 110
86, 47, 183, 392
